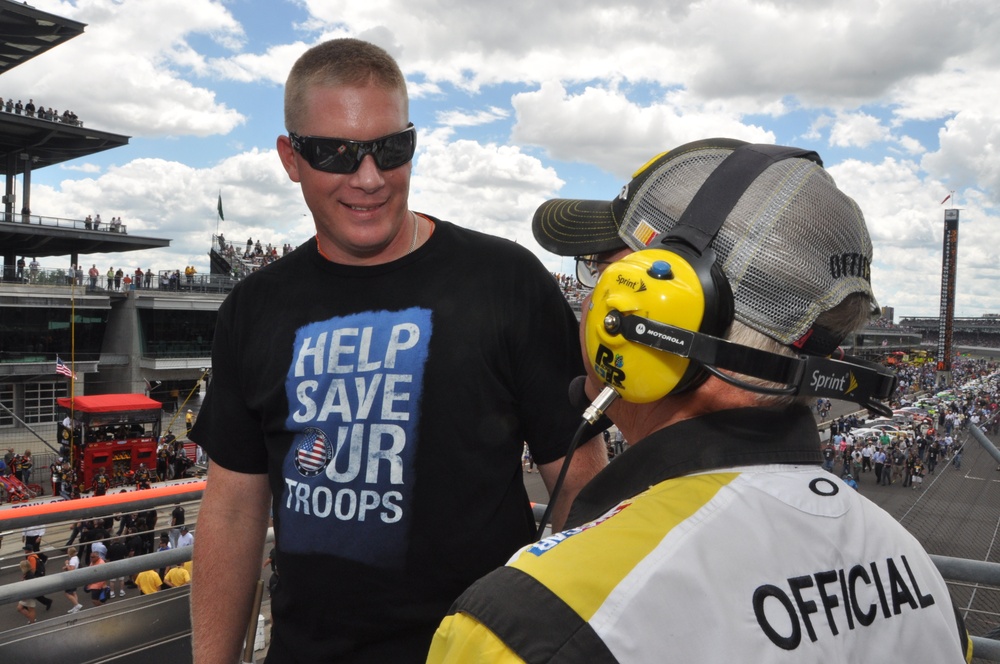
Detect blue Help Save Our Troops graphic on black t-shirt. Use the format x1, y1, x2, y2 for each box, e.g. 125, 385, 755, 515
278, 308, 431, 568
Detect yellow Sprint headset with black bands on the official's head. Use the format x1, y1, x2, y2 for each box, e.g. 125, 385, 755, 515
585, 143, 896, 414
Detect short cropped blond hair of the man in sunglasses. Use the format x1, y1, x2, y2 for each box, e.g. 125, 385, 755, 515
285, 38, 410, 132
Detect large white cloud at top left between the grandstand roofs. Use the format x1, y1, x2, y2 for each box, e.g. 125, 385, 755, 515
11, 0, 245, 136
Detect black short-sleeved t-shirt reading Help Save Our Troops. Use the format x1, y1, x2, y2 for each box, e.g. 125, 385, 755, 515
190, 220, 583, 662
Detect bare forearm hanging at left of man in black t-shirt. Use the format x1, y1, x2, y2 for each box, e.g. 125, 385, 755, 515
191, 463, 271, 664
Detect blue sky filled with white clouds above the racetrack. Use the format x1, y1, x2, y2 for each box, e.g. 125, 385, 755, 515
7, 0, 1000, 321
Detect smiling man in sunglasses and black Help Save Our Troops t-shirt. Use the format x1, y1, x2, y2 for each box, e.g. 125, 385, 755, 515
190, 39, 606, 663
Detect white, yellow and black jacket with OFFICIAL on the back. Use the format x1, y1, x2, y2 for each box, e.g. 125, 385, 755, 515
428, 408, 972, 664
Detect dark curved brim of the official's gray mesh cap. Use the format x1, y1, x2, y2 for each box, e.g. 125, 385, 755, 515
531, 198, 625, 256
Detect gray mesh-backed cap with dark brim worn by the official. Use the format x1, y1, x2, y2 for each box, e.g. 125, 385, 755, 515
533, 139, 877, 346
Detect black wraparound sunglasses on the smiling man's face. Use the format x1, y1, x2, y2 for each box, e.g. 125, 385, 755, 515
288, 122, 417, 174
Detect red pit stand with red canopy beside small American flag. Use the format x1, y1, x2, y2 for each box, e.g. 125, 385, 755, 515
58, 394, 163, 491
